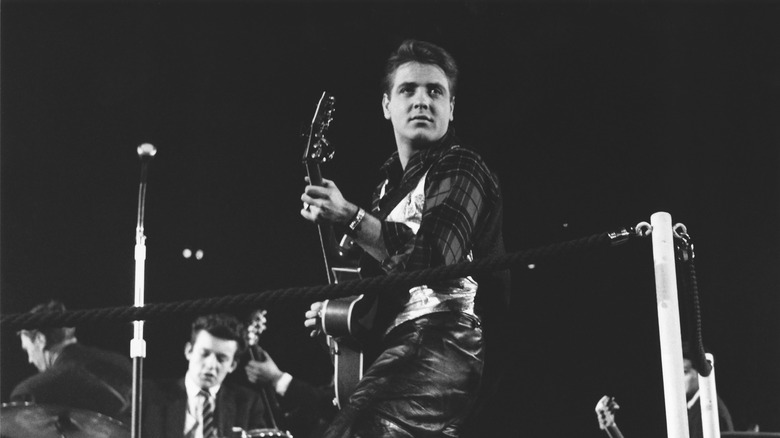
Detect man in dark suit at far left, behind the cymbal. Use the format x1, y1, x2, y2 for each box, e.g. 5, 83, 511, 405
11, 300, 133, 424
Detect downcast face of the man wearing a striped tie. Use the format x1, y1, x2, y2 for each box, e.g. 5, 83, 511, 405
184, 330, 238, 389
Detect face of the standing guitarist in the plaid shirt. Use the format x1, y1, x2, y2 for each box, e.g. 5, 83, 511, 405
382, 62, 455, 149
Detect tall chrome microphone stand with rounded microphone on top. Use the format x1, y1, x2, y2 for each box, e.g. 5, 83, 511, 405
130, 143, 157, 438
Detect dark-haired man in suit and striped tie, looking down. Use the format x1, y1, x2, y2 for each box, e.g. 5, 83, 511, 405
141, 314, 269, 438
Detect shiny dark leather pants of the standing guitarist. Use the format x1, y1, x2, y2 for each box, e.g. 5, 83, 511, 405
324, 312, 483, 438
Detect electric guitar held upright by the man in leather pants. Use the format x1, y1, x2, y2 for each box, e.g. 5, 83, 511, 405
303, 92, 376, 408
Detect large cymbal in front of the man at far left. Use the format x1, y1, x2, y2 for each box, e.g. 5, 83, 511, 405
0, 403, 130, 438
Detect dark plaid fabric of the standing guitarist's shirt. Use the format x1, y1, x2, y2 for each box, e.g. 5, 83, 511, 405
372, 134, 500, 272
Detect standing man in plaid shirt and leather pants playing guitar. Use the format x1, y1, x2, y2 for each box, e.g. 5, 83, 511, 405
301, 40, 508, 438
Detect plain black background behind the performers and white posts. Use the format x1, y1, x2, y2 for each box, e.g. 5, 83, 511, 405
0, 1, 780, 437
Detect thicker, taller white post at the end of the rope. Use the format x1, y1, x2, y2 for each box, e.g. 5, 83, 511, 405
650, 212, 688, 438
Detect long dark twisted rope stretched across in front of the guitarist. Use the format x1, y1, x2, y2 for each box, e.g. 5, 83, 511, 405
0, 228, 635, 330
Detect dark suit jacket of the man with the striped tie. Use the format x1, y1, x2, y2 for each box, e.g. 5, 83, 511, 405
141, 378, 270, 438
